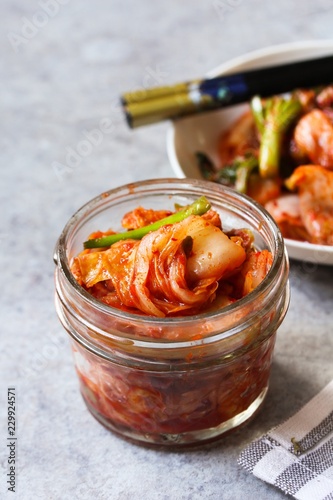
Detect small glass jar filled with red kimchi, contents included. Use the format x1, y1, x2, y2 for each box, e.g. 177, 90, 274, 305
55, 179, 289, 446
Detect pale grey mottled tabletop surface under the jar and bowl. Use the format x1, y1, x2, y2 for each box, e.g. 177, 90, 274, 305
0, 0, 333, 500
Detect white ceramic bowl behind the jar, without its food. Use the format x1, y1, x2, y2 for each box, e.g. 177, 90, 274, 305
167, 40, 333, 265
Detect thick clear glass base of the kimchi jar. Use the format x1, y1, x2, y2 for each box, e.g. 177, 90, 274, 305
83, 386, 268, 448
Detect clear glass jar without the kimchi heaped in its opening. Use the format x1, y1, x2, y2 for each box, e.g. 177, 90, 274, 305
55, 179, 289, 446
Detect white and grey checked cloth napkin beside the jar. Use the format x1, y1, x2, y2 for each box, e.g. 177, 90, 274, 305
238, 380, 333, 500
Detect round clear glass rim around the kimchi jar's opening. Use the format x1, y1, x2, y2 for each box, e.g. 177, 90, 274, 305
54, 178, 288, 344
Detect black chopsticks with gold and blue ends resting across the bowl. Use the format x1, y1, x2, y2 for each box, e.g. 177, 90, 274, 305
121, 55, 333, 128
